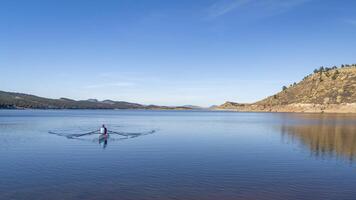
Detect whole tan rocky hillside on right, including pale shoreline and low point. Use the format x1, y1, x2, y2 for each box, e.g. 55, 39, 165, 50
218, 65, 356, 112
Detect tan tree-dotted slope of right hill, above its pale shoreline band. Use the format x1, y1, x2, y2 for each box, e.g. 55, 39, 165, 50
257, 67, 356, 105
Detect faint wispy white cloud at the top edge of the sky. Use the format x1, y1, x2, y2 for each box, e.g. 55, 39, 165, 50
208, 0, 310, 18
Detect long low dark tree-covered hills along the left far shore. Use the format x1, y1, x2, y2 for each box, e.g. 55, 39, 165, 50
0, 91, 192, 110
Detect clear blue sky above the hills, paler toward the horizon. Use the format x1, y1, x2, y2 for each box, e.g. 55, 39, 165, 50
0, 0, 356, 106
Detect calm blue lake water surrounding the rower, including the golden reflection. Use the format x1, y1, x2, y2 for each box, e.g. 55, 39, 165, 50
0, 110, 356, 200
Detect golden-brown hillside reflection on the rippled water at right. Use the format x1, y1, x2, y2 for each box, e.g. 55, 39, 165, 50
281, 124, 356, 160
